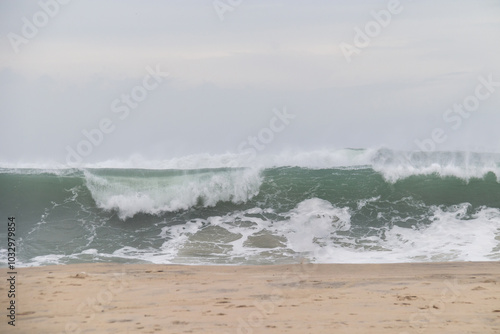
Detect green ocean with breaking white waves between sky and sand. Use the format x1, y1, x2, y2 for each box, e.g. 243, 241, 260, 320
0, 149, 500, 267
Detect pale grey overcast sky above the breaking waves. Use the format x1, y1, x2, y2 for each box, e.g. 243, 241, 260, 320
0, 0, 500, 163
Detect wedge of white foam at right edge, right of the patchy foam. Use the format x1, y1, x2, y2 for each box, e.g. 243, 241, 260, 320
314, 203, 500, 263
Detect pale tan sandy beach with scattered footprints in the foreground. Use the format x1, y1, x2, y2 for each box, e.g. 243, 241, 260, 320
0, 262, 500, 334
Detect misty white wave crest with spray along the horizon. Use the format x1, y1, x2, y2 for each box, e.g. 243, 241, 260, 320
0, 148, 500, 182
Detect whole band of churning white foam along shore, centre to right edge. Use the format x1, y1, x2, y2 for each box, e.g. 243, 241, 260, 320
153, 198, 500, 263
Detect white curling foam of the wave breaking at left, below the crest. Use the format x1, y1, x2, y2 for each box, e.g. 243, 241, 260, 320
85, 169, 262, 219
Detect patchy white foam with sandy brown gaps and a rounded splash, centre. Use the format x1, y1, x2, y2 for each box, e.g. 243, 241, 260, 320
156, 198, 350, 263
